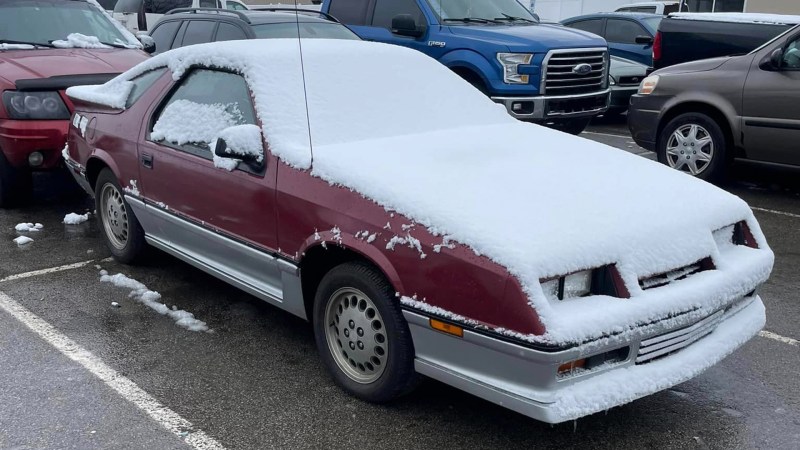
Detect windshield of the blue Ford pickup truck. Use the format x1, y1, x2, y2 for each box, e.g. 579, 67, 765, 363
428, 0, 538, 23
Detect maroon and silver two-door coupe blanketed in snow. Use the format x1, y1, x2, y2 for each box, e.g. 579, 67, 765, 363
64, 39, 773, 423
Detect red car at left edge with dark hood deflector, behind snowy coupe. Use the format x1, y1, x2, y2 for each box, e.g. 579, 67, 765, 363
0, 0, 148, 207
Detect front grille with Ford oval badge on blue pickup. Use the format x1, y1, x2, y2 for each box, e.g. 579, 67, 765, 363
542, 49, 608, 95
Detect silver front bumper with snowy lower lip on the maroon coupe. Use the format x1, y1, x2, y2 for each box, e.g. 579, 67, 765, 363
403, 295, 766, 423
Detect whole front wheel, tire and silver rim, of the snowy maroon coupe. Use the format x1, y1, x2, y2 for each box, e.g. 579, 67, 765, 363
314, 262, 417, 403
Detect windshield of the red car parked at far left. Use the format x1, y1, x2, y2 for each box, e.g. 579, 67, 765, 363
0, 0, 128, 47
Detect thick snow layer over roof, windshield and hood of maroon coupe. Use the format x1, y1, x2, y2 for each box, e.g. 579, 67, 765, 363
68, 40, 773, 342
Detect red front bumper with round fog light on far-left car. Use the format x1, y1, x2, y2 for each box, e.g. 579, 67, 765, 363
0, 119, 69, 170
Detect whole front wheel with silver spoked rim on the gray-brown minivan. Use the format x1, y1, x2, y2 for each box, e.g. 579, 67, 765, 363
656, 113, 728, 182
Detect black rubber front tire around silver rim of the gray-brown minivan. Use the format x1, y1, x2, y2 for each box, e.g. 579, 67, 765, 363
656, 113, 729, 182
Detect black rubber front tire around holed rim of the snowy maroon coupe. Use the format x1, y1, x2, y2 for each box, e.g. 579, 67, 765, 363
313, 262, 418, 403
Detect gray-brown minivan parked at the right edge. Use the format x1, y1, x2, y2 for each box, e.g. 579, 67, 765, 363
628, 26, 800, 181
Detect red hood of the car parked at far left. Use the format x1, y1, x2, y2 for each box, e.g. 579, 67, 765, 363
0, 48, 149, 88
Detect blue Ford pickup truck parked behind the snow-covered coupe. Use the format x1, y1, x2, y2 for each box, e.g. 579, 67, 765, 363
322, 0, 609, 134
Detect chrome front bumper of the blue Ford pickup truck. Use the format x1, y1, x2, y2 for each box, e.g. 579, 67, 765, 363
492, 89, 609, 121
